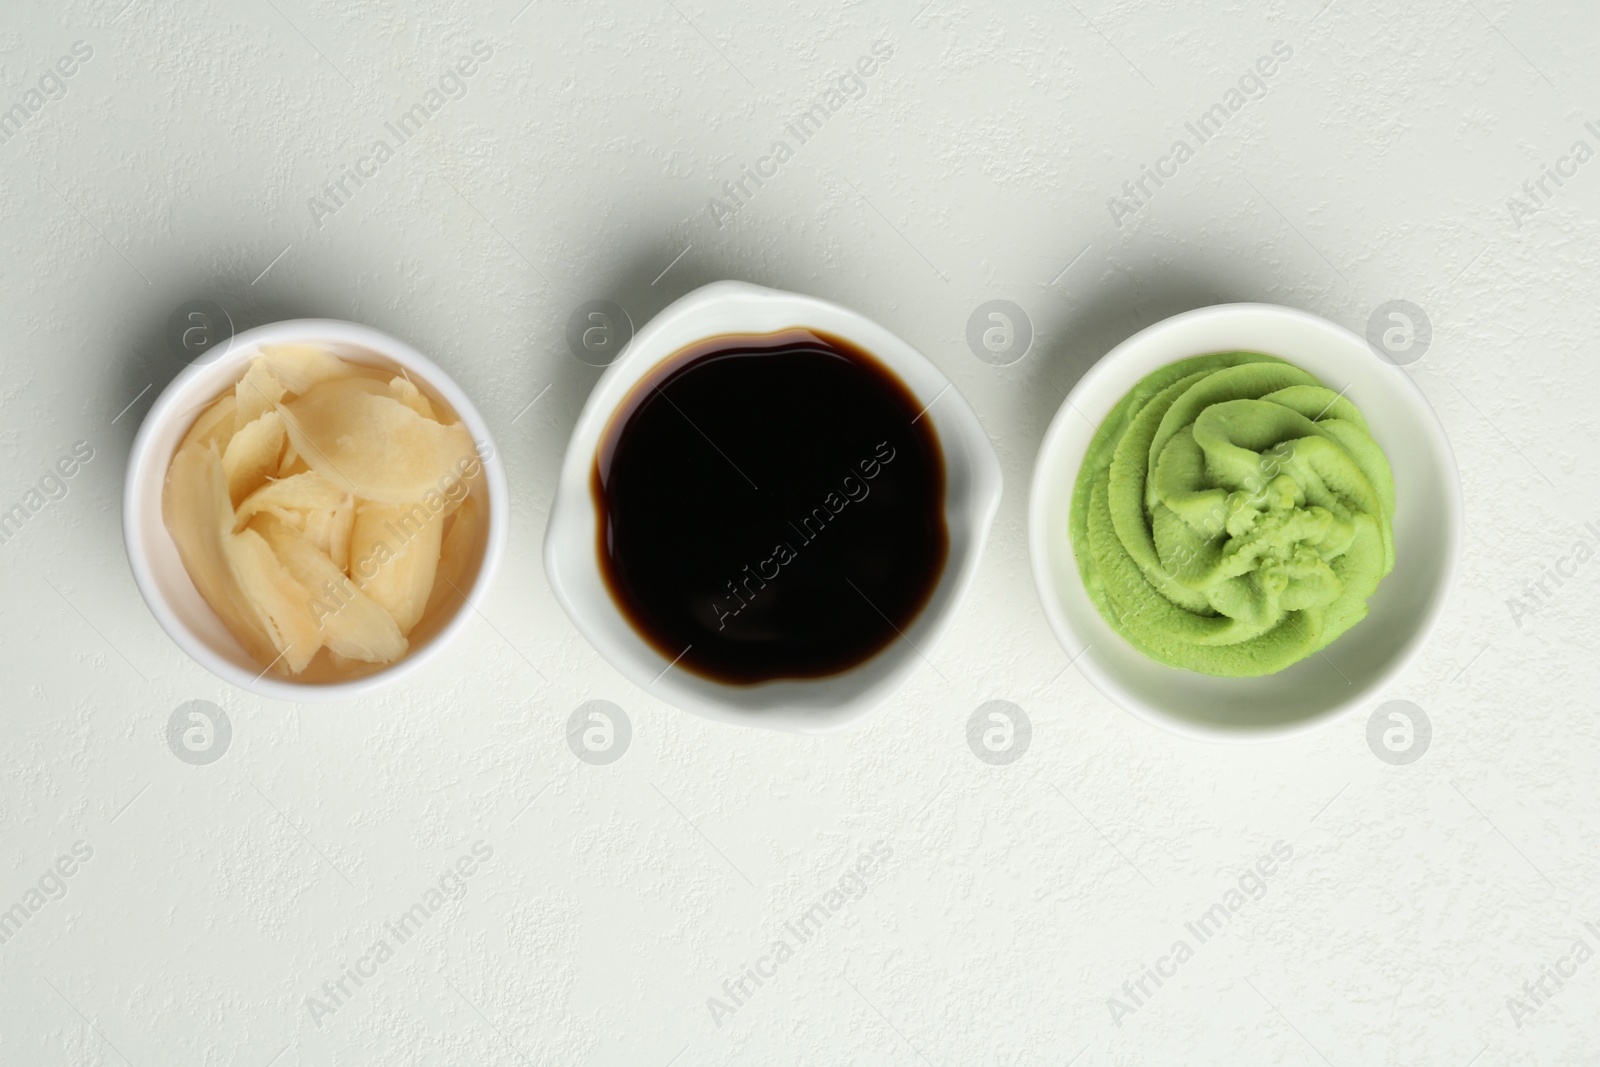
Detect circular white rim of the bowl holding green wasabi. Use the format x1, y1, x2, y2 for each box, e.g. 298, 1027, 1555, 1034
1027, 295, 1464, 744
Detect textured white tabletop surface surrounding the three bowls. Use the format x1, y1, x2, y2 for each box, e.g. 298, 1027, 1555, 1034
0, 0, 1600, 1067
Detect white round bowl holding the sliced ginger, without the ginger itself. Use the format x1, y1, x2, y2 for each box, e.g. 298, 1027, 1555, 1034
122, 318, 509, 701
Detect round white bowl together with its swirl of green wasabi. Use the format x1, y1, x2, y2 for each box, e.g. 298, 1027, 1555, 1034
1029, 304, 1461, 741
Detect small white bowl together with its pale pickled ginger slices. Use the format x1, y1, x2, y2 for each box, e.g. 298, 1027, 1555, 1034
123, 320, 507, 701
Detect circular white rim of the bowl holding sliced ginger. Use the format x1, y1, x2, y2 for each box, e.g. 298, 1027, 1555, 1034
122, 318, 509, 704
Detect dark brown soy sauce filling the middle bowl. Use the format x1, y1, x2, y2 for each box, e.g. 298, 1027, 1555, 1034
592, 330, 949, 685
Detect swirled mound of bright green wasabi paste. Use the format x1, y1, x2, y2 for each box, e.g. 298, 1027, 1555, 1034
1070, 352, 1395, 678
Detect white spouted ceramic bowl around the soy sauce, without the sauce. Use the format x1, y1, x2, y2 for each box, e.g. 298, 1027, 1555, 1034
544, 282, 1000, 733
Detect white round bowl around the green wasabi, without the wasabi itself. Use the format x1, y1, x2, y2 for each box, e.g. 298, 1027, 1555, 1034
1029, 304, 1461, 741
